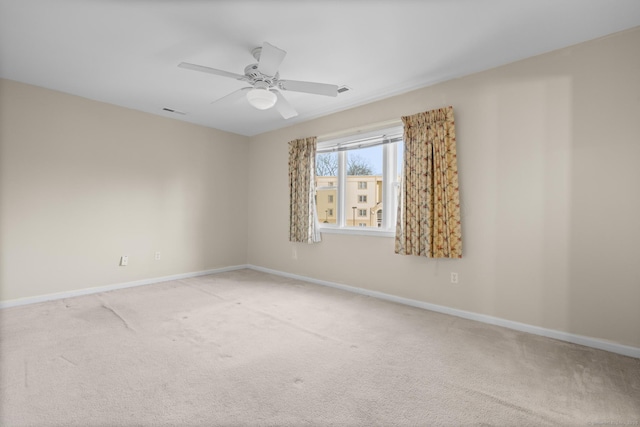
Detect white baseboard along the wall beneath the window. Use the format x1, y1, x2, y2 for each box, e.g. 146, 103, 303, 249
247, 264, 640, 359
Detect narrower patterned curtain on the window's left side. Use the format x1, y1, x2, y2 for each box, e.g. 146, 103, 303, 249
289, 136, 321, 243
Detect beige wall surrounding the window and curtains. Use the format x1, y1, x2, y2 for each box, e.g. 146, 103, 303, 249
248, 29, 640, 347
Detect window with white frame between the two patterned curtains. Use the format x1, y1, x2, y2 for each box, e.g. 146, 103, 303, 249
316, 125, 403, 236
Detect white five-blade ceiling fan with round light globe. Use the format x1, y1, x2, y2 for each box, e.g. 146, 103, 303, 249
178, 42, 338, 119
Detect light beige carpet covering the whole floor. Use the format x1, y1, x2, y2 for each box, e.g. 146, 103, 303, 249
0, 270, 640, 426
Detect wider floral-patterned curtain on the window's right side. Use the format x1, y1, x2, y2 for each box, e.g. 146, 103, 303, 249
395, 107, 462, 258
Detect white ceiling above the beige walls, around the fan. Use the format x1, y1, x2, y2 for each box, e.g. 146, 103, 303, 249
0, 0, 640, 136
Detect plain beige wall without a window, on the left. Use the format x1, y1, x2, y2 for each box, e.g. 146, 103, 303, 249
0, 80, 249, 300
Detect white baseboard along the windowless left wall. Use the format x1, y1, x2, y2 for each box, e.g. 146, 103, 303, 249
0, 265, 250, 309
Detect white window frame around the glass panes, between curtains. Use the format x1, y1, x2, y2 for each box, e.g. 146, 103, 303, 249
318, 123, 403, 237
